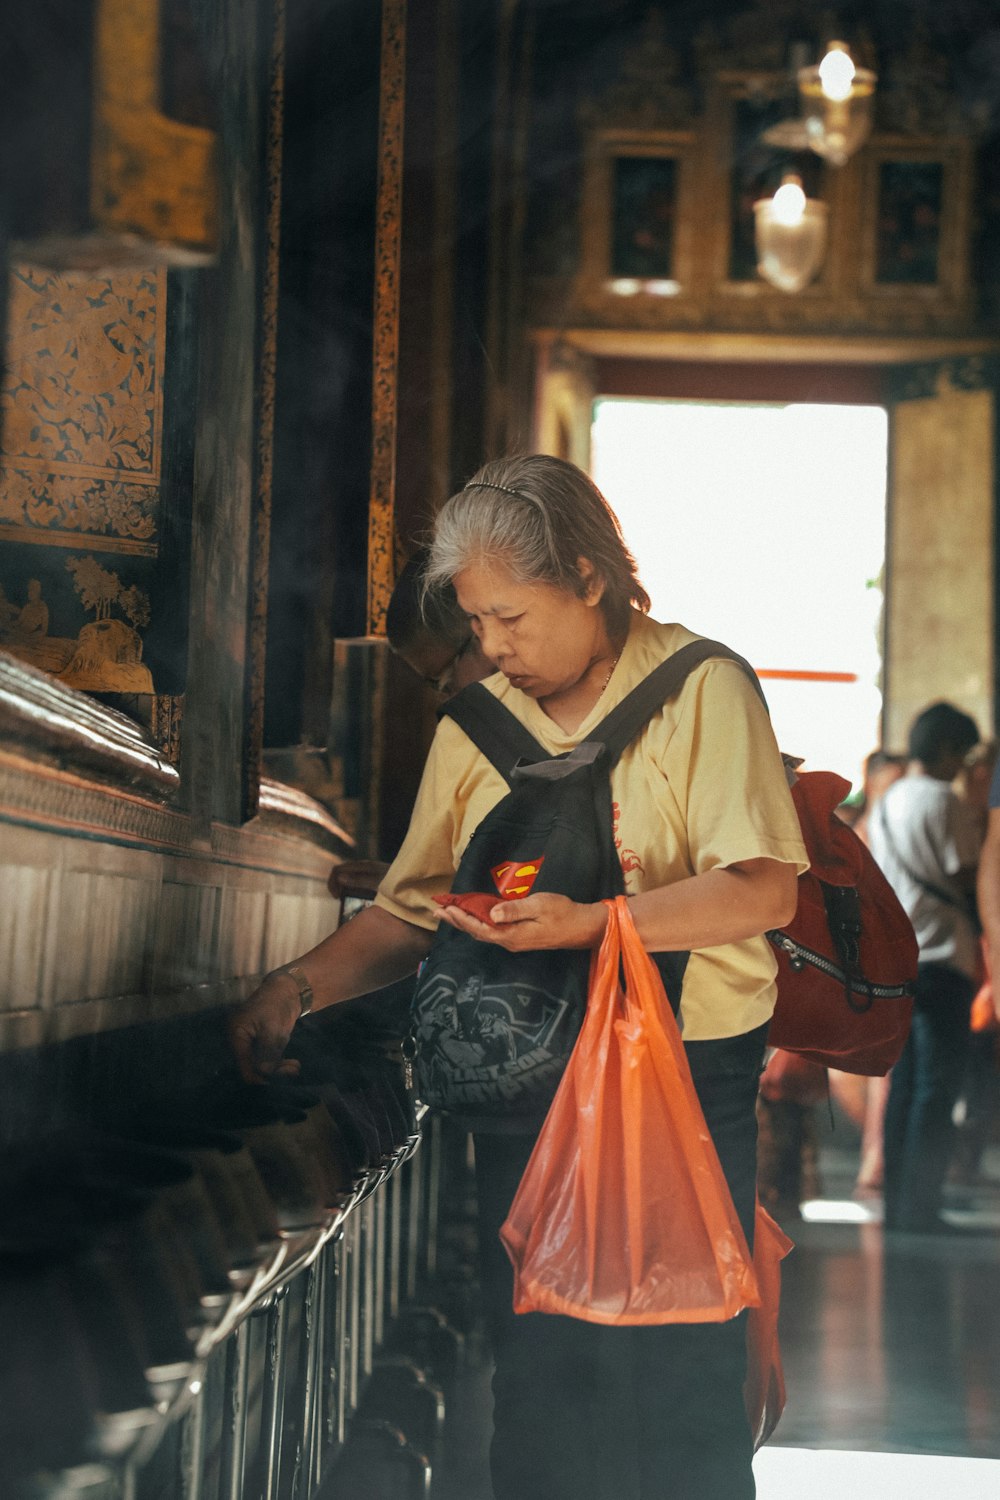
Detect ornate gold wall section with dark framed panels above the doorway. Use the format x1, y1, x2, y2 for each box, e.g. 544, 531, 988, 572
528, 12, 981, 348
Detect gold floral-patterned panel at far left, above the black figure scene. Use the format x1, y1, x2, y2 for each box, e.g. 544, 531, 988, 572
0, 266, 166, 557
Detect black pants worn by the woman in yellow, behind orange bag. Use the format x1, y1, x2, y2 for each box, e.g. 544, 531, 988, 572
475, 1028, 766, 1500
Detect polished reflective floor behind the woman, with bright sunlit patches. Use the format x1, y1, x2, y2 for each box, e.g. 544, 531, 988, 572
435, 1142, 1000, 1500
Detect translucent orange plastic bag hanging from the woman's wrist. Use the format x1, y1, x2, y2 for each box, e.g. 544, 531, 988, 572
501, 897, 760, 1325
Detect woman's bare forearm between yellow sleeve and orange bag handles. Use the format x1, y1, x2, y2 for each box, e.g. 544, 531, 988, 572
628, 860, 798, 953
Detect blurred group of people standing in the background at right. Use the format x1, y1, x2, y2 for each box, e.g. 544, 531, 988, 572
759, 704, 1000, 1233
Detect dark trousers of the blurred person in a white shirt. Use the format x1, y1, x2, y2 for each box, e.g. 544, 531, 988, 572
885, 963, 975, 1230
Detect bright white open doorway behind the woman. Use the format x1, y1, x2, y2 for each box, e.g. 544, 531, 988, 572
591, 398, 888, 785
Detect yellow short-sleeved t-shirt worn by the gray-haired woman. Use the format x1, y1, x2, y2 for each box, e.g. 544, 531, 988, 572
375, 612, 808, 1041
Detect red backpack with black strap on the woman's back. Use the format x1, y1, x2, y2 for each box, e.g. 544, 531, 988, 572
656, 641, 918, 1076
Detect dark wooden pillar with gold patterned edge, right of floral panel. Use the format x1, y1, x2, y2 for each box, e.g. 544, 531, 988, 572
181, 0, 274, 828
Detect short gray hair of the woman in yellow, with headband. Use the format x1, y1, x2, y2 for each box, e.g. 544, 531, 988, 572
424, 453, 649, 636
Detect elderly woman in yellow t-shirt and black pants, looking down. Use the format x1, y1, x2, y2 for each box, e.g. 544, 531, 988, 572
231, 455, 807, 1500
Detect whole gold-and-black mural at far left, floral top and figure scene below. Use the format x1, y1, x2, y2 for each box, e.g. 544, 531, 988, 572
0, 266, 166, 693
